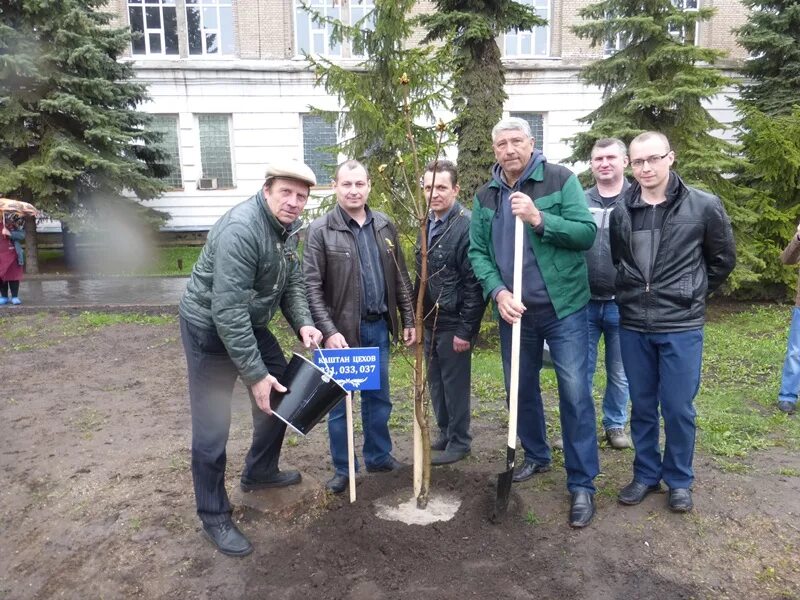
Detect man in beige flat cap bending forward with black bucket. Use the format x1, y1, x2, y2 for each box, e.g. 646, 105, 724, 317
179, 161, 322, 556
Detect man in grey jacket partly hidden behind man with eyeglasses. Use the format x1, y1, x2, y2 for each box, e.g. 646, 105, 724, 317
586, 138, 631, 448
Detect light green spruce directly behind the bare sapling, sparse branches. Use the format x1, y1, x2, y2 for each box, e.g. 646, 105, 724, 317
306, 0, 450, 231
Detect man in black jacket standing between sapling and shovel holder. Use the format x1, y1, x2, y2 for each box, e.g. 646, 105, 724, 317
415, 160, 486, 465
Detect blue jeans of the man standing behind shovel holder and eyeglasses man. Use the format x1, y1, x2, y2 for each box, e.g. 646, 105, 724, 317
587, 300, 628, 429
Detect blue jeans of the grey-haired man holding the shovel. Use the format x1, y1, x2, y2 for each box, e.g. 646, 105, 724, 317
500, 307, 600, 493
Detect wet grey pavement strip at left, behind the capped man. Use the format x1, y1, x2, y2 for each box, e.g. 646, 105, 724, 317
5, 277, 189, 315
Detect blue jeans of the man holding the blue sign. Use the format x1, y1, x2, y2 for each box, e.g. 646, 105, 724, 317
328, 319, 392, 475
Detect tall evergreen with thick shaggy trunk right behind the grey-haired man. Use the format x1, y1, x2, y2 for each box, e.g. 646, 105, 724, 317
419, 0, 547, 202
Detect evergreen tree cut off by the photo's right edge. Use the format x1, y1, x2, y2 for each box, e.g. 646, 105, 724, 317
735, 0, 800, 297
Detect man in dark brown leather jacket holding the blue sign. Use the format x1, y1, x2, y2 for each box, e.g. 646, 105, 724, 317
303, 160, 416, 494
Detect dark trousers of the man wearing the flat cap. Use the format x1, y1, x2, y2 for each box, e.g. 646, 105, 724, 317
180, 317, 286, 524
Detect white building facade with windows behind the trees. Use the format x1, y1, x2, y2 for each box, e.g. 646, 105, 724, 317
103, 0, 746, 232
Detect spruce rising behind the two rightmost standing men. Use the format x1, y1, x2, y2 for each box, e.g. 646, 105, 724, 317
568, 0, 760, 288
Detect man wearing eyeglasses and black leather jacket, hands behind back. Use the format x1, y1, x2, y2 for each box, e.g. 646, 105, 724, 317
611, 131, 736, 512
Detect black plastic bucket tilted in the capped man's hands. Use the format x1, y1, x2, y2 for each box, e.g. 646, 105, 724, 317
270, 353, 347, 435
